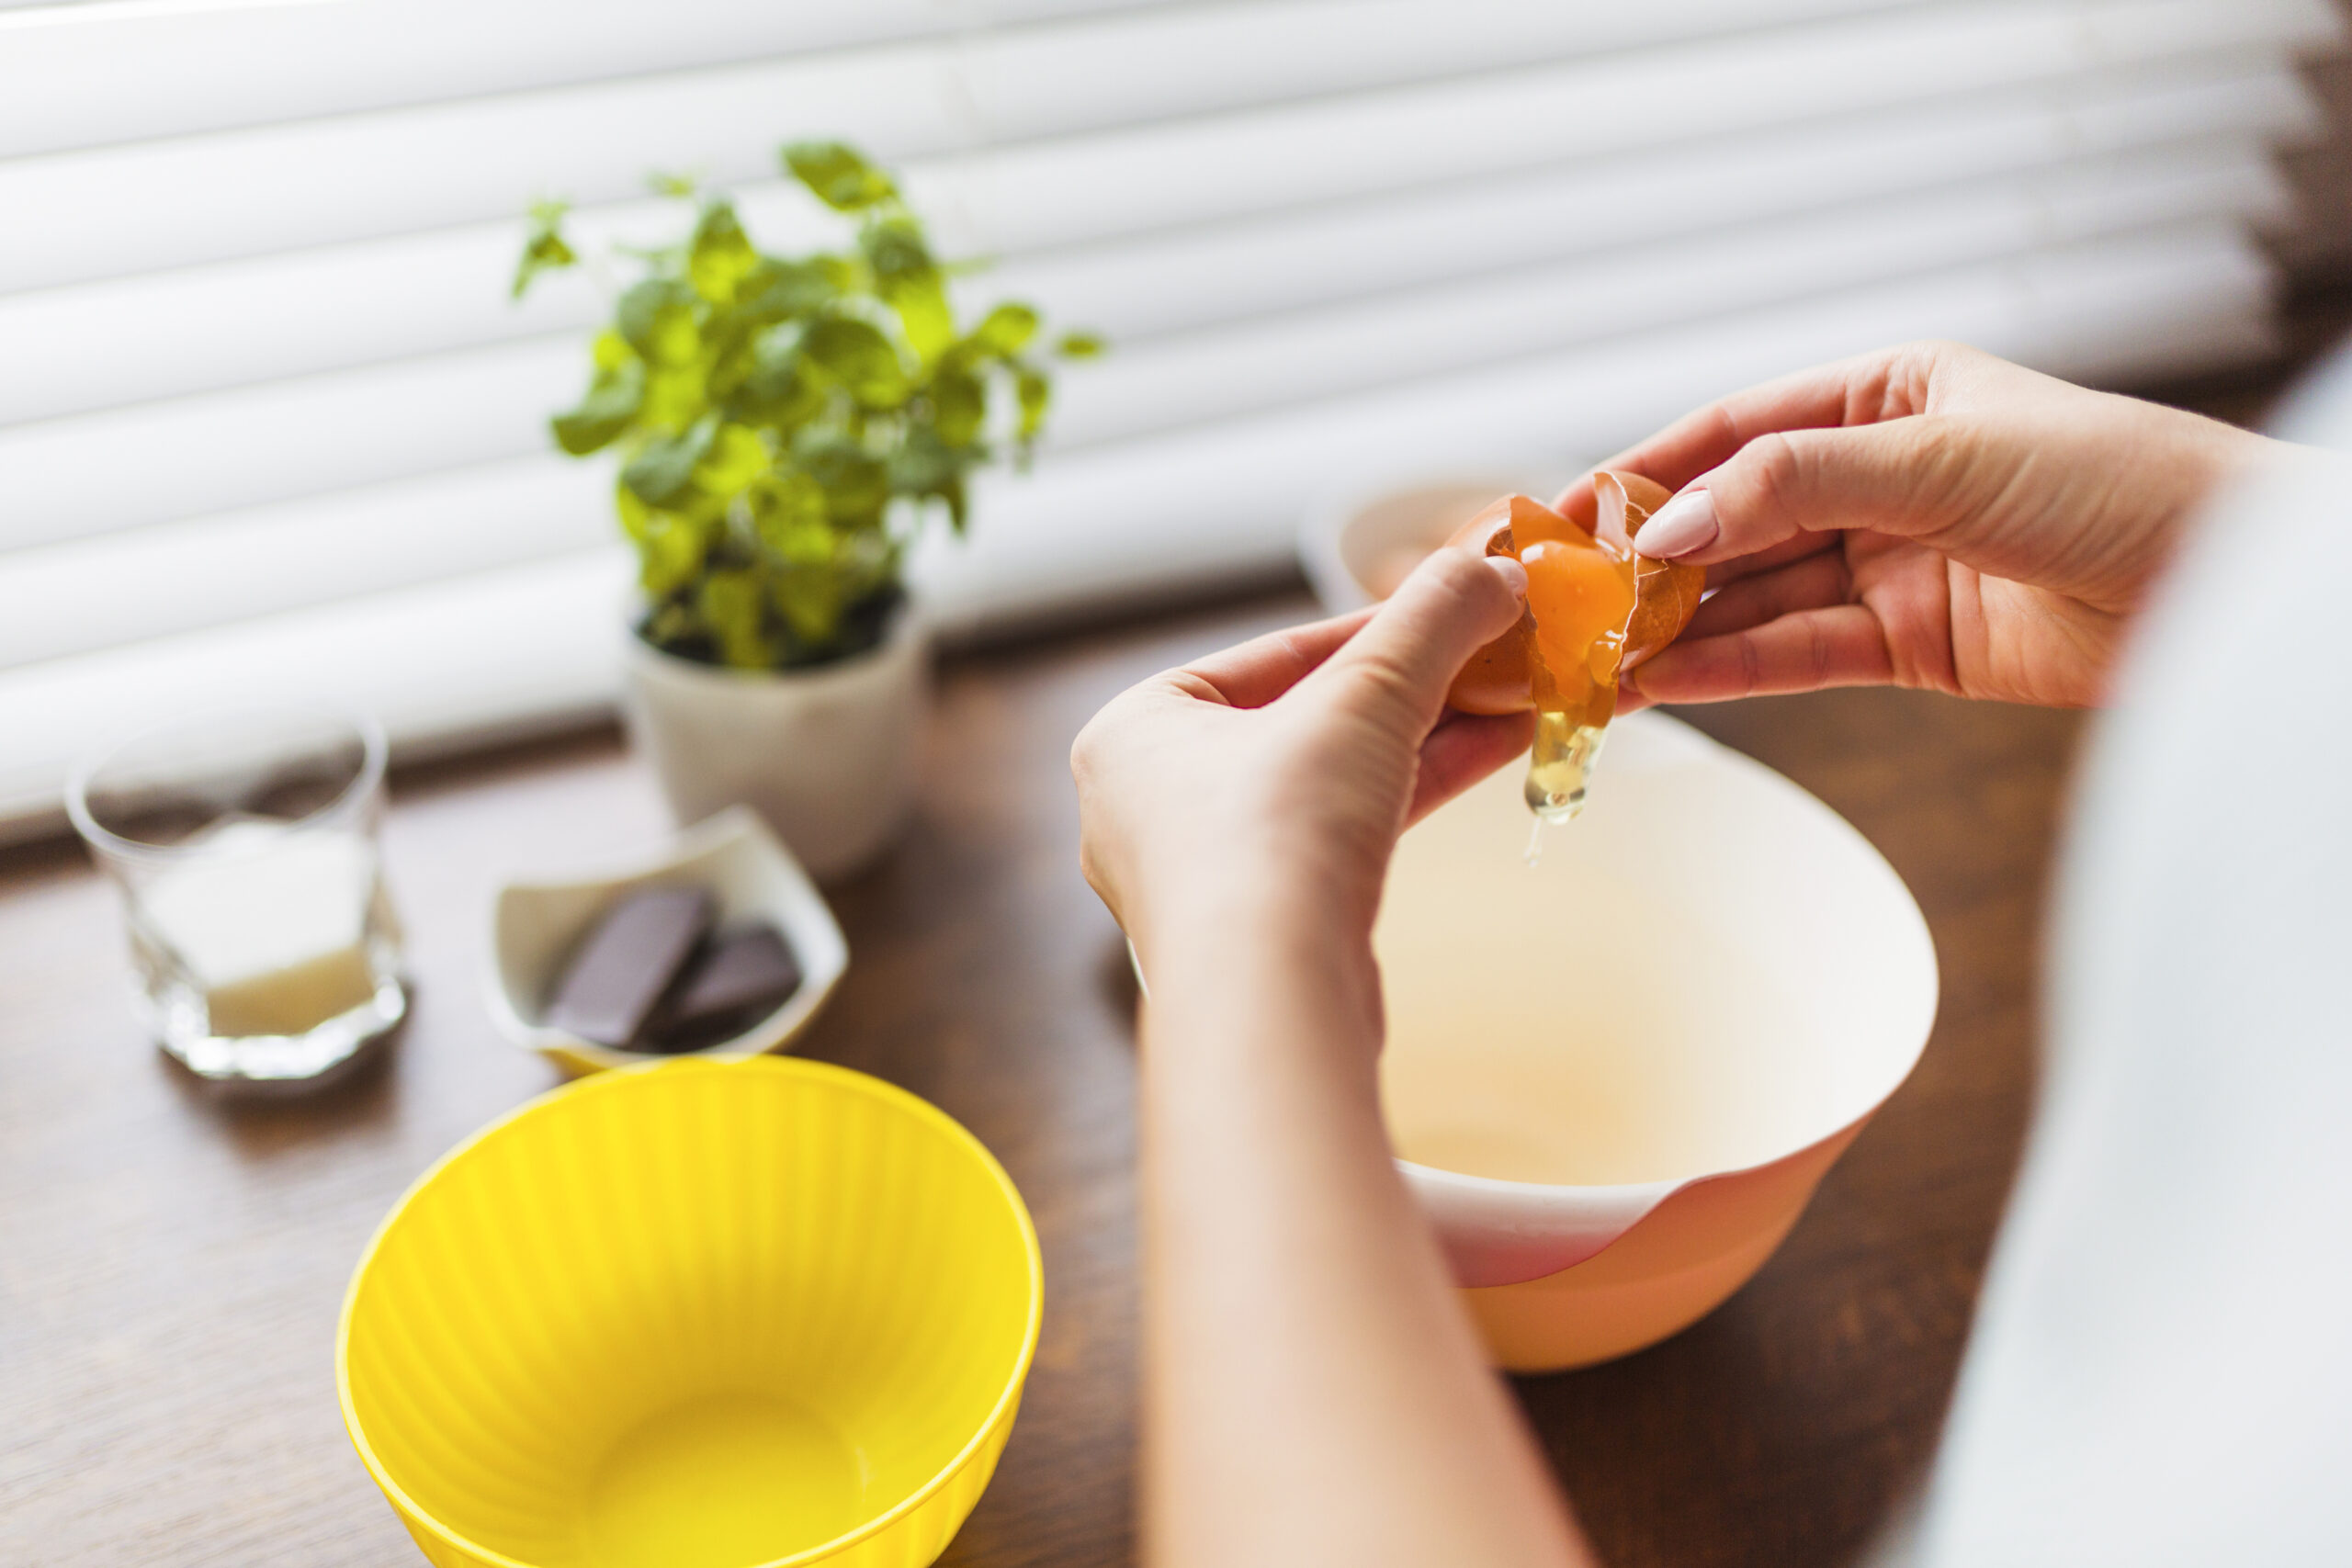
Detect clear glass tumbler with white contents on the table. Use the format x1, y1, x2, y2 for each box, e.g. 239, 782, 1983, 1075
66, 707, 407, 1084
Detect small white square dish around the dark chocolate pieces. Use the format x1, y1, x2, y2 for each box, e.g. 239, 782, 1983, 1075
487, 807, 849, 1072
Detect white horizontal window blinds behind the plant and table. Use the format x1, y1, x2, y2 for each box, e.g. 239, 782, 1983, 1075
0, 0, 2338, 831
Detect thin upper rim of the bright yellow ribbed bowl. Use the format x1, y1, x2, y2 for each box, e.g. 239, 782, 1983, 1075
334, 1055, 1045, 1568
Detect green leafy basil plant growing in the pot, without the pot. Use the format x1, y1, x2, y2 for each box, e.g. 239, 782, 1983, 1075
515, 141, 1103, 670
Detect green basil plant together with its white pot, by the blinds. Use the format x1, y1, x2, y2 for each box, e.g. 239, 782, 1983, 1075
515, 141, 1101, 877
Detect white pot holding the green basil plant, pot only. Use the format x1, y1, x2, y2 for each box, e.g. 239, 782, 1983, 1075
626, 606, 929, 882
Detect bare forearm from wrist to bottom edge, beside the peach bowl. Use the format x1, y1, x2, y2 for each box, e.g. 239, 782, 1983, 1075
1143, 908, 1590, 1568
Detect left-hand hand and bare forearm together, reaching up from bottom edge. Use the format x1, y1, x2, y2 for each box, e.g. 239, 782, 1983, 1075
1070, 550, 1592, 1568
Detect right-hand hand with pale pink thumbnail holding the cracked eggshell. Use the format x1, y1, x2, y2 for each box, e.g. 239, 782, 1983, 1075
1562, 344, 2277, 707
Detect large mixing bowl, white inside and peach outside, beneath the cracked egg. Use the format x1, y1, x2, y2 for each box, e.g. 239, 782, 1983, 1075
1374, 712, 1936, 1371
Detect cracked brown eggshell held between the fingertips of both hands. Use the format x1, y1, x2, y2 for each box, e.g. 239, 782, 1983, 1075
1446, 481, 1708, 712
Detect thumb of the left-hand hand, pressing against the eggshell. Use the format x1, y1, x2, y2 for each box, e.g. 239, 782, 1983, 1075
1301, 547, 1526, 745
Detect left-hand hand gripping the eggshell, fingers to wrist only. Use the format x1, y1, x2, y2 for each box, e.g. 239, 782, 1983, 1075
1070, 550, 1532, 959
